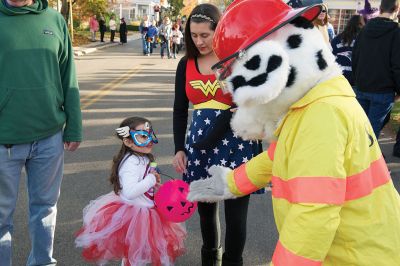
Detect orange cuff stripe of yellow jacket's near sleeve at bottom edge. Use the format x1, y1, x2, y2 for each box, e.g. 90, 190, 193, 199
272, 241, 322, 266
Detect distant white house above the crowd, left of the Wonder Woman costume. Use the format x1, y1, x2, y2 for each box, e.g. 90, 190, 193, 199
109, 0, 169, 21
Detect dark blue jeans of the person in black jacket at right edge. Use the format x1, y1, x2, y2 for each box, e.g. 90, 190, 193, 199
355, 89, 395, 139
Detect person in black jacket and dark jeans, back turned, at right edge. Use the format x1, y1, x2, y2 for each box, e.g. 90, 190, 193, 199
352, 0, 400, 139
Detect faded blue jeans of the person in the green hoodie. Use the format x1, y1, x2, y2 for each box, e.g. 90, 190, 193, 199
0, 131, 64, 266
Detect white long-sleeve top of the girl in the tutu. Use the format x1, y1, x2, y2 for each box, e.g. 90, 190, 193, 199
118, 155, 156, 208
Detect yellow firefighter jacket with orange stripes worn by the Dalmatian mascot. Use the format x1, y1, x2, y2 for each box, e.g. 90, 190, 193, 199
228, 76, 400, 266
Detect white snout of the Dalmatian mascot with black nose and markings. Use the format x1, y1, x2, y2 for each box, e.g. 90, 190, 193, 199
227, 41, 290, 106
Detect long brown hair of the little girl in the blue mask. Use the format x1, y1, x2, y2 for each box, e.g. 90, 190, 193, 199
109, 117, 154, 194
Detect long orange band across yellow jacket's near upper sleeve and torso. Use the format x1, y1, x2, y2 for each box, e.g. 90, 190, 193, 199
272, 157, 390, 205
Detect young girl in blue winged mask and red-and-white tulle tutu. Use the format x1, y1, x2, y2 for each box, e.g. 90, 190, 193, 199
75, 117, 186, 266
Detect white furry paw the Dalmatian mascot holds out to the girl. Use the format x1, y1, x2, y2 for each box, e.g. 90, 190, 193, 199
187, 165, 236, 202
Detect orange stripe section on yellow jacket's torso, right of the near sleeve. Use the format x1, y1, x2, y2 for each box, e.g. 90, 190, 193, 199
346, 156, 390, 200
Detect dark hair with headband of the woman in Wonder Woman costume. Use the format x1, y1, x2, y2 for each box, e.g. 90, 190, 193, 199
185, 3, 221, 58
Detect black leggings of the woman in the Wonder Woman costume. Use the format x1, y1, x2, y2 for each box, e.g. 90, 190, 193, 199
198, 195, 250, 261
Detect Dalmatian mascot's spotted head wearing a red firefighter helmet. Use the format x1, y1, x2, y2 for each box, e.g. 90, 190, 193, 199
213, 0, 341, 139
